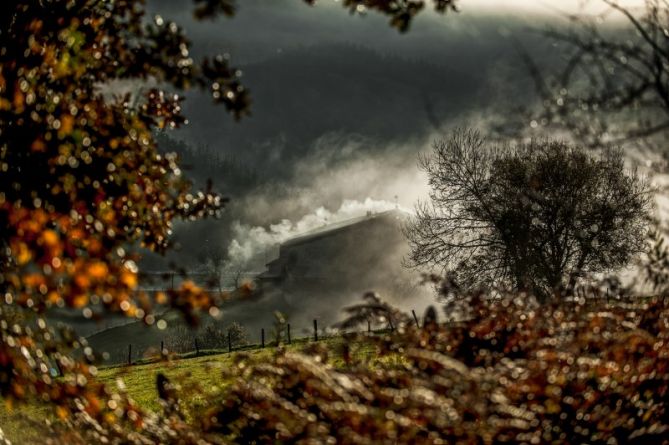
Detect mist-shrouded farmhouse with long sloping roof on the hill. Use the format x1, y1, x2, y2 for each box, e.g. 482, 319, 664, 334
243, 210, 434, 327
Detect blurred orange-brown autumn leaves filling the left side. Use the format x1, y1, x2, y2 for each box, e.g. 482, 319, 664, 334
0, 1, 248, 440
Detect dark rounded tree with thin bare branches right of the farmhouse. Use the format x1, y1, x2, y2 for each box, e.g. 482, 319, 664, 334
405, 130, 651, 299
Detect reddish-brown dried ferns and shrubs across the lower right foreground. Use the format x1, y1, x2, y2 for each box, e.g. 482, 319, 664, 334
194, 294, 669, 444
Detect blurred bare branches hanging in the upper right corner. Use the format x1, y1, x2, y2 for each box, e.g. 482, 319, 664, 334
526, 0, 669, 151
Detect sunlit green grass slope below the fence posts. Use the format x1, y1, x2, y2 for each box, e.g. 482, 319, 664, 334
0, 337, 373, 444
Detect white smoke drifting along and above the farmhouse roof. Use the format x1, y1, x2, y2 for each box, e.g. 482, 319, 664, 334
222, 133, 429, 272
